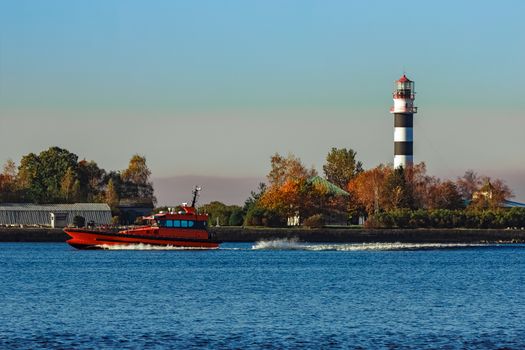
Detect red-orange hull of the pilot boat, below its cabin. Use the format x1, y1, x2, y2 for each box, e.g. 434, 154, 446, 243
64, 229, 221, 249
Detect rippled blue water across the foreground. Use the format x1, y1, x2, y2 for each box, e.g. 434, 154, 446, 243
0, 241, 525, 349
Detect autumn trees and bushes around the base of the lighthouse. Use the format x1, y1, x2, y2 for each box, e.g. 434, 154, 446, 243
207, 148, 525, 228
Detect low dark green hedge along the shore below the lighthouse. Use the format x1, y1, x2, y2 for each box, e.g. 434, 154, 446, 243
366, 208, 525, 228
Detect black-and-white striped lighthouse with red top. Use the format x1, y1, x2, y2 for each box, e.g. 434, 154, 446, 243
390, 74, 417, 169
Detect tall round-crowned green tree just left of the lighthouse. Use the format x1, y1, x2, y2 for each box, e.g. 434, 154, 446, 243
323, 147, 363, 189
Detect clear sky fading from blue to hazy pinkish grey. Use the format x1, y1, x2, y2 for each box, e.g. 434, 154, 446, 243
0, 0, 525, 204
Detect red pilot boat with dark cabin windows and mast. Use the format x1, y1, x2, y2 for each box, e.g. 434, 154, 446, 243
64, 188, 221, 249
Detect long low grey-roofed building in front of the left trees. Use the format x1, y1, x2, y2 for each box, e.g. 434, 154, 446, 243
0, 203, 111, 227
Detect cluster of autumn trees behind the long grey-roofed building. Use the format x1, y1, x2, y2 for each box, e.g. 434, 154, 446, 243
0, 147, 156, 214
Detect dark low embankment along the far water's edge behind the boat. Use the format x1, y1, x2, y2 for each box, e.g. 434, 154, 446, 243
0, 226, 525, 243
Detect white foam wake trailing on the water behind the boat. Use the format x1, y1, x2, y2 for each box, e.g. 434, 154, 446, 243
252, 238, 487, 251
